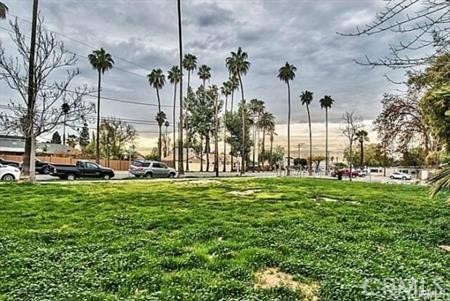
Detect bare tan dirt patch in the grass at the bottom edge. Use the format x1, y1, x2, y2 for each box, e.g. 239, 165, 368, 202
255, 268, 319, 301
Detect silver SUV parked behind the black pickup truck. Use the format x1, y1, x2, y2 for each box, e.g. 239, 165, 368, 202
129, 160, 177, 178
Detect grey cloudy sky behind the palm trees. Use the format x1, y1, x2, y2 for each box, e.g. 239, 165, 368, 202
0, 0, 408, 155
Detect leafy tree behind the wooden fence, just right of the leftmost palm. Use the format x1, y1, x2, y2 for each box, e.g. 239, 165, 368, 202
99, 118, 137, 159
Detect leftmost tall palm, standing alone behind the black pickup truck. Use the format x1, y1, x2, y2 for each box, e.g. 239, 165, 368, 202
88, 48, 114, 163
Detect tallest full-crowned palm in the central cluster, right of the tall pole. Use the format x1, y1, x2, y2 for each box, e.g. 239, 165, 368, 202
226, 47, 250, 174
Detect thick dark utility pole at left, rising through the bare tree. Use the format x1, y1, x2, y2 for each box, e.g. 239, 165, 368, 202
24, 0, 38, 183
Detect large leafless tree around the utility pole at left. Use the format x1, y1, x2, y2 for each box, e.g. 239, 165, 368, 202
0, 17, 95, 181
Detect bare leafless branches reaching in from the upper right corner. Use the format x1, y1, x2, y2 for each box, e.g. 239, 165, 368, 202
341, 0, 450, 69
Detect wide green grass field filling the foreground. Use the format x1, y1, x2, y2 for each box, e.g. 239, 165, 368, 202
0, 178, 450, 300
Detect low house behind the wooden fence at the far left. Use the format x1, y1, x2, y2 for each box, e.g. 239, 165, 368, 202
0, 135, 73, 156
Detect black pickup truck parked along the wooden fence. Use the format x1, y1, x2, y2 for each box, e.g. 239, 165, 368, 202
50, 160, 115, 181
